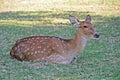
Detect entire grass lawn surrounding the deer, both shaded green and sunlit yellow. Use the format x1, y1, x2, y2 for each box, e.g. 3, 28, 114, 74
0, 0, 120, 80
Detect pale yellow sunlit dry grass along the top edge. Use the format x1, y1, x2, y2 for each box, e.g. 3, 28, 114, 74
0, 0, 120, 16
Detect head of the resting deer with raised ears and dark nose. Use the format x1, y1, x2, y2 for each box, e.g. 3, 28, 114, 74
69, 15, 99, 38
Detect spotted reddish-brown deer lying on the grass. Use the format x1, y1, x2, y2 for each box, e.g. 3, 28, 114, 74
10, 15, 99, 64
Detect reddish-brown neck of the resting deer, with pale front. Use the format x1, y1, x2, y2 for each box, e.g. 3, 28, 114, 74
71, 30, 87, 53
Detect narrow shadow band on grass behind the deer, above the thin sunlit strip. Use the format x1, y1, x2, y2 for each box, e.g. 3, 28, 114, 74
0, 11, 90, 21
